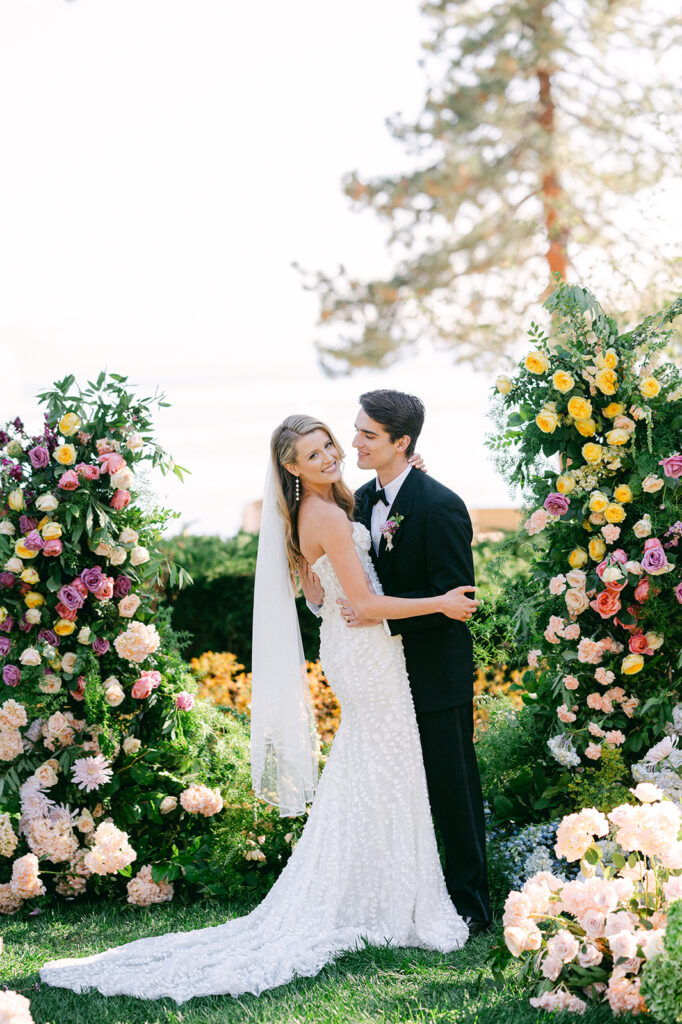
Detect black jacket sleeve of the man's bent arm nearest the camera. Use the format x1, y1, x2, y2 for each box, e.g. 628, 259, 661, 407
388, 495, 474, 635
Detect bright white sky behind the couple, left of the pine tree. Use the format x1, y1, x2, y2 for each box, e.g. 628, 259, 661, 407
0, 0, 675, 535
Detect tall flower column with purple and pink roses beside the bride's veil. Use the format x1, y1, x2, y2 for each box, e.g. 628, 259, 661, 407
0, 374, 241, 913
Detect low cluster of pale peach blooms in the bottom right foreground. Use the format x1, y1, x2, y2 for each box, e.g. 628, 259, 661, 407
503, 782, 682, 1015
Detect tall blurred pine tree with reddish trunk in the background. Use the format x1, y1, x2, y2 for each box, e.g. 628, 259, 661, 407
312, 0, 682, 372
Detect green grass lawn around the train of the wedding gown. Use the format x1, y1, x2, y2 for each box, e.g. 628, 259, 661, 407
0, 903, 634, 1024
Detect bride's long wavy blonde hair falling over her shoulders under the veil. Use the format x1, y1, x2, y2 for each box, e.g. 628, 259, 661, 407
270, 416, 354, 589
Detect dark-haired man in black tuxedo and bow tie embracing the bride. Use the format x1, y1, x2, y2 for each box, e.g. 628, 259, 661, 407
304, 390, 491, 934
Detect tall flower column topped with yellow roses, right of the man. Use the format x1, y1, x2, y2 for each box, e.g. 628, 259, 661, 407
488, 285, 682, 814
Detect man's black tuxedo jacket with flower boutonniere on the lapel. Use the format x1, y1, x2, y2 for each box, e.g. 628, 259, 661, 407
354, 469, 474, 712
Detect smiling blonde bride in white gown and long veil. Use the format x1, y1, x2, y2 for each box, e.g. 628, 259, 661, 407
40, 416, 472, 1004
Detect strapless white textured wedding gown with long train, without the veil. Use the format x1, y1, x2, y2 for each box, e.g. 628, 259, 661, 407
40, 523, 468, 1004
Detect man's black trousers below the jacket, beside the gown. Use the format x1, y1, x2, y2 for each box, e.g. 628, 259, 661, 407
417, 700, 491, 923
